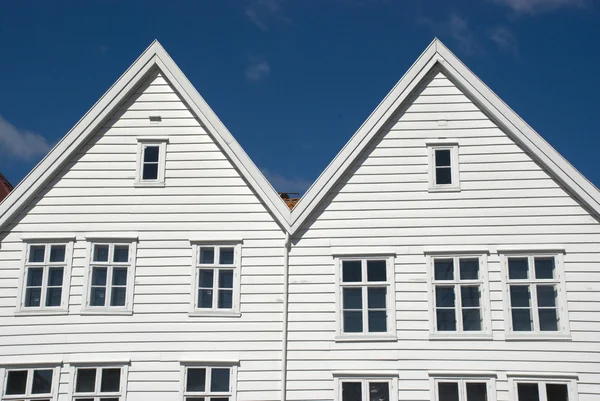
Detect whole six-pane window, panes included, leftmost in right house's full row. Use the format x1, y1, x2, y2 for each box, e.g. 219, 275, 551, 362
339, 257, 395, 336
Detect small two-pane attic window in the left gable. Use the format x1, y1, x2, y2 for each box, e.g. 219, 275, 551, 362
136, 138, 168, 186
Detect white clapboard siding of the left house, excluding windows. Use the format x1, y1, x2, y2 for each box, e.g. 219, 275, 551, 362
0, 69, 284, 401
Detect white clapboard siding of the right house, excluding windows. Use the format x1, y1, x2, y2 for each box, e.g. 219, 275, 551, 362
288, 73, 600, 401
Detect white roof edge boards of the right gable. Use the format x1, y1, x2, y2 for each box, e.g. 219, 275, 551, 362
290, 38, 600, 233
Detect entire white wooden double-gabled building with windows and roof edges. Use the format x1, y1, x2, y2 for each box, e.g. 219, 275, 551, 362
0, 39, 600, 401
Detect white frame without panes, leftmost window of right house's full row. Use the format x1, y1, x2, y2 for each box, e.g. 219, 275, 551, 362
334, 254, 398, 341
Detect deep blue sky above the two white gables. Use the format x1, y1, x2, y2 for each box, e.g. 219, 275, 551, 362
0, 0, 600, 191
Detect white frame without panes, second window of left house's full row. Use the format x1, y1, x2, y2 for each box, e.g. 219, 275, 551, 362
81, 237, 137, 315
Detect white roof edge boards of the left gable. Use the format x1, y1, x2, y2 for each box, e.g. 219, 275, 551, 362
0, 40, 290, 231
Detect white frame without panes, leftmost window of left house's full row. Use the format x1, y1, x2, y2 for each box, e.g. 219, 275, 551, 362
15, 237, 75, 315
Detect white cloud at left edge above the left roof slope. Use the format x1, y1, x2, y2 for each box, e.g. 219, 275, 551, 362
0, 116, 51, 161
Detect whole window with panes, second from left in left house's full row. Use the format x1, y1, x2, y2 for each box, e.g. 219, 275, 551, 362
86, 242, 136, 310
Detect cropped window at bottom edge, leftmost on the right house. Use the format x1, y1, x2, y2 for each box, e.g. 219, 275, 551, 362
337, 377, 397, 401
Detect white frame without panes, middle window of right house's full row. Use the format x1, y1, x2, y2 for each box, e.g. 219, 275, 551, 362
425, 252, 492, 340
